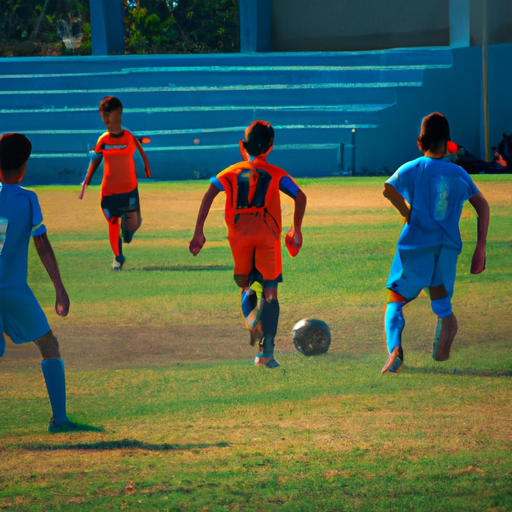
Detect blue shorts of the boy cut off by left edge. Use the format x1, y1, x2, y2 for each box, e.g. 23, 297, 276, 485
0, 284, 50, 357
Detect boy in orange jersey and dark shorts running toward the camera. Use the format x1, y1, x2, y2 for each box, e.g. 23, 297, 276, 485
80, 96, 151, 270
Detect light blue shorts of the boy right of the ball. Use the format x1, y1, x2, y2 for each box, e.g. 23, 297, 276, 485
386, 246, 459, 301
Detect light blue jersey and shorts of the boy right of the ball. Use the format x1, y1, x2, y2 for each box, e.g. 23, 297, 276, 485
386, 157, 479, 300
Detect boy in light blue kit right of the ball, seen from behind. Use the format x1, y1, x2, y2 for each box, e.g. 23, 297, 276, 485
382, 112, 490, 374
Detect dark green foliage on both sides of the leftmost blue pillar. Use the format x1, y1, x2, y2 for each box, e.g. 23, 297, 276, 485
0, 0, 240, 57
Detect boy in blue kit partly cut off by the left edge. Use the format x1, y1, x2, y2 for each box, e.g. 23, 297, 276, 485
0, 133, 76, 432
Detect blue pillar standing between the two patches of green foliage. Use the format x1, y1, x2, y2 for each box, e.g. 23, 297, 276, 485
89, 0, 124, 55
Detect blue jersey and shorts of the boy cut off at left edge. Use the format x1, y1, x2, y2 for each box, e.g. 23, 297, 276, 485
0, 183, 50, 357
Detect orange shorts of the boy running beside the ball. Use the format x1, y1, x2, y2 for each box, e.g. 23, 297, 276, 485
228, 213, 283, 281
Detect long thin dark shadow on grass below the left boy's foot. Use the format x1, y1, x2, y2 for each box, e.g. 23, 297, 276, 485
20, 439, 229, 452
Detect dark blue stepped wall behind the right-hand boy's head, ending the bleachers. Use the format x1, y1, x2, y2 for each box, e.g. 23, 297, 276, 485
357, 47, 484, 171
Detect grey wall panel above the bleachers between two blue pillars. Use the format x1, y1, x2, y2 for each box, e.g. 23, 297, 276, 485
272, 0, 449, 52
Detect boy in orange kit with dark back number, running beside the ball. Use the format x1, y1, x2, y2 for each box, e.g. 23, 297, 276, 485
189, 121, 306, 368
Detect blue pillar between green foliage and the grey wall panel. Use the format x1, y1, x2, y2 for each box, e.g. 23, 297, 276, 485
238, 0, 272, 53
